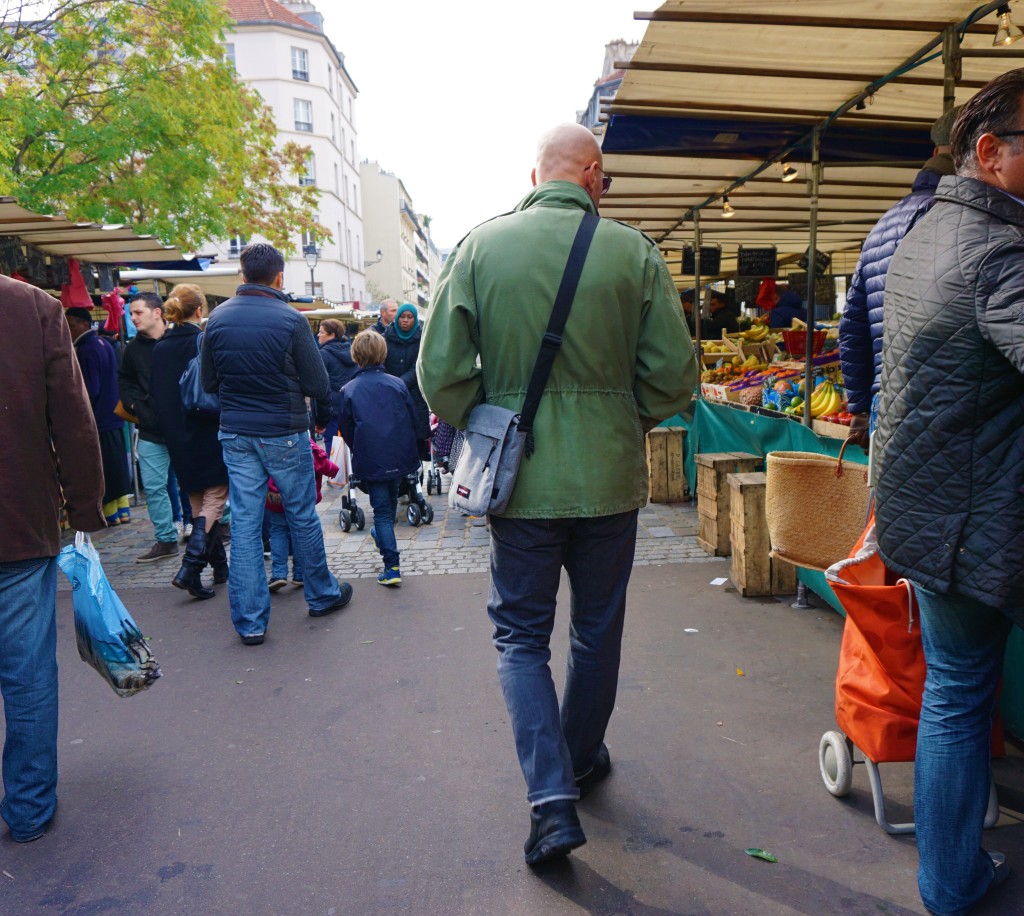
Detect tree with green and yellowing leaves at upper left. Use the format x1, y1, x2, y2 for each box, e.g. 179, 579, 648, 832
0, 0, 331, 253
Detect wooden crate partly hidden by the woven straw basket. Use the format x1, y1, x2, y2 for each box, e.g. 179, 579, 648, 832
728, 473, 797, 598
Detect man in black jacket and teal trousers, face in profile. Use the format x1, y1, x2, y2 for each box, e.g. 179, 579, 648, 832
118, 293, 178, 563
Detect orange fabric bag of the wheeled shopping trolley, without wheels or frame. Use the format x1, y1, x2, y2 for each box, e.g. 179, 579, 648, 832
828, 514, 1006, 764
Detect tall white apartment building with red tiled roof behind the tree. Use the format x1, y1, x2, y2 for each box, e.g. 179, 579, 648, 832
214, 0, 370, 304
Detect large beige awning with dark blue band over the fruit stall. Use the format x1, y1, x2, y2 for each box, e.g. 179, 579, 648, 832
601, 0, 1024, 286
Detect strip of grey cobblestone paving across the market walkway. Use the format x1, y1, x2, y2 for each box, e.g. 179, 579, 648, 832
59, 478, 711, 588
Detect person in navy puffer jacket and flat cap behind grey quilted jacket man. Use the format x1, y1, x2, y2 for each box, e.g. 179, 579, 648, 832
839, 108, 959, 450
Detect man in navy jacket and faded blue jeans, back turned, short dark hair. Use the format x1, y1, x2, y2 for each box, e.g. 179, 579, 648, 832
202, 244, 352, 646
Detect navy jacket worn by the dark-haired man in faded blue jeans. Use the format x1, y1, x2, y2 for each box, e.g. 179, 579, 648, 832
203, 283, 331, 436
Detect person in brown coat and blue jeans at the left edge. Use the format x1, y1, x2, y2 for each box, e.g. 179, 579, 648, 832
0, 276, 105, 842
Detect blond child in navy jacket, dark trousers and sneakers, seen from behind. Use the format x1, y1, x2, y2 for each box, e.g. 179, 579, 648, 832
338, 331, 420, 586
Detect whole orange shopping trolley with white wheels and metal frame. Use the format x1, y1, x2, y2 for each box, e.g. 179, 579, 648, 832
818, 517, 1005, 834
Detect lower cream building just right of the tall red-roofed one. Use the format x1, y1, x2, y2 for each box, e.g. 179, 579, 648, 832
359, 162, 428, 308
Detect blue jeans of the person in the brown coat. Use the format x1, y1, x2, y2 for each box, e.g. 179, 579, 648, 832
0, 557, 57, 837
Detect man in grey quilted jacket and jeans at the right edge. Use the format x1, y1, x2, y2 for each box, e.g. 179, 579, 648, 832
874, 70, 1024, 913
